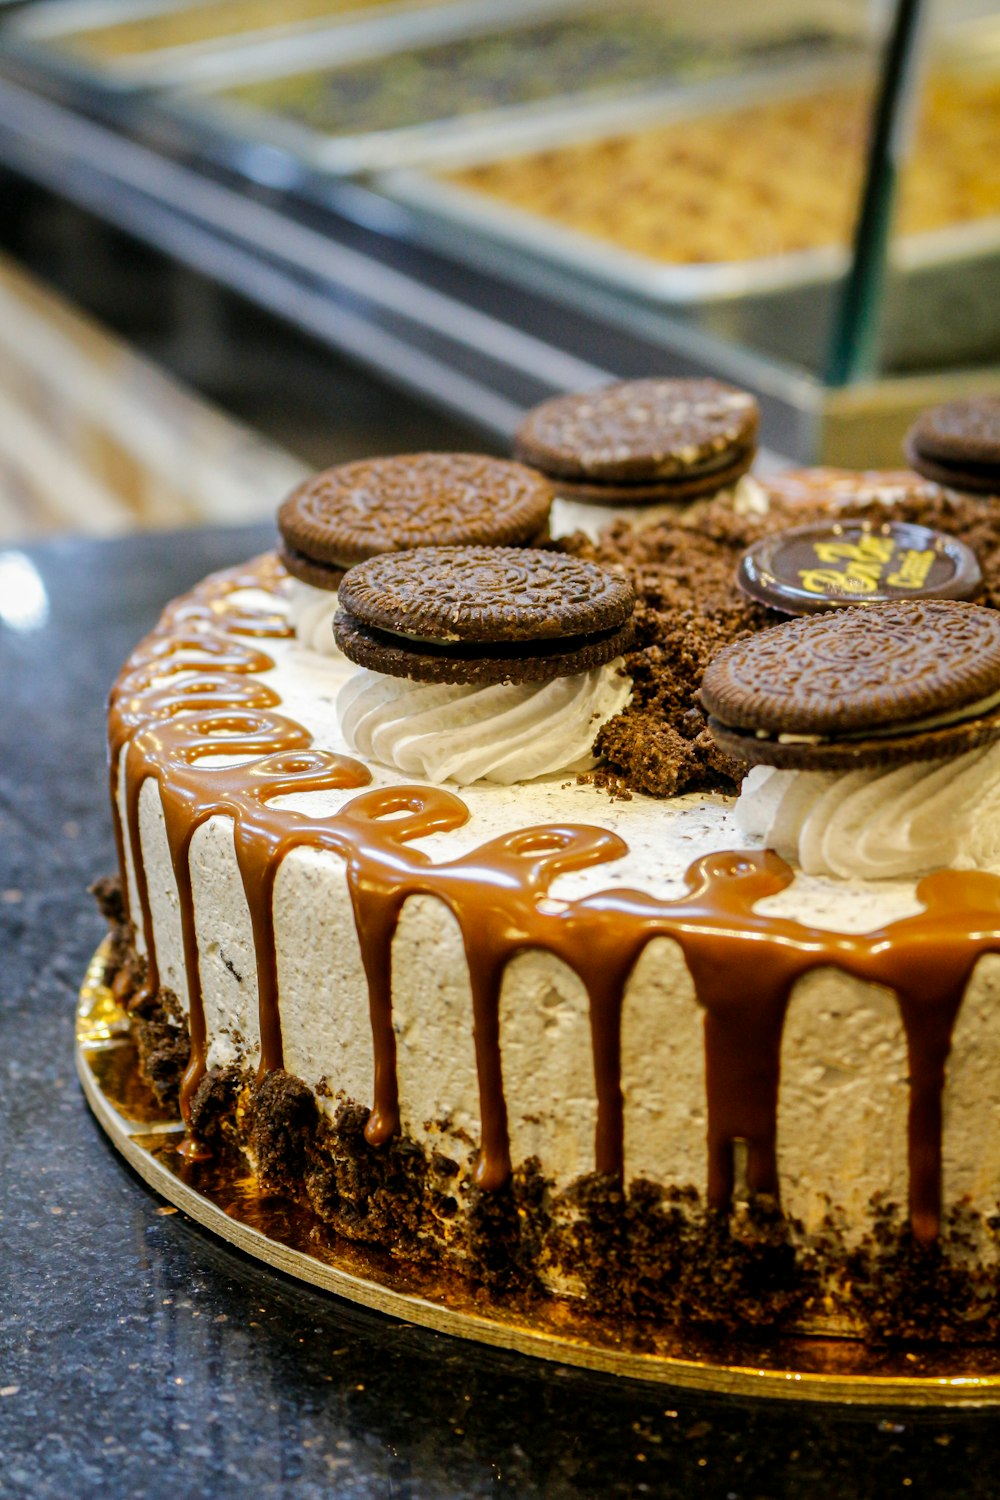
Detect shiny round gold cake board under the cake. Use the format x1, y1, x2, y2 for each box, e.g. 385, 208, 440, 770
76, 945, 1000, 1407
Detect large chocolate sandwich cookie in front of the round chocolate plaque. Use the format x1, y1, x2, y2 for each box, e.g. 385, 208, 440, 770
702, 600, 1000, 771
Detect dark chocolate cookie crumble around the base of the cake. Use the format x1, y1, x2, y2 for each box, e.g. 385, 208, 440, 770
94, 900, 1000, 1347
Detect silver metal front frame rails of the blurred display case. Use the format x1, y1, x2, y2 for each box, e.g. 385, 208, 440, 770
0, 8, 996, 462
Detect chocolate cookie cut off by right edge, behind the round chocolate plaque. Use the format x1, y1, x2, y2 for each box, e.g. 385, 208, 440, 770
904, 396, 1000, 495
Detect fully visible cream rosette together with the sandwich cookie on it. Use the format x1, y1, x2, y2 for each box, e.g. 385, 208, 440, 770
334, 548, 634, 785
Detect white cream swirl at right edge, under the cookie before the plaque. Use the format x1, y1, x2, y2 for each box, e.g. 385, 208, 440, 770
735, 744, 1000, 881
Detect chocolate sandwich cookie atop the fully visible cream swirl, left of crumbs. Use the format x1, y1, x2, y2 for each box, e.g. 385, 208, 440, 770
333, 548, 634, 683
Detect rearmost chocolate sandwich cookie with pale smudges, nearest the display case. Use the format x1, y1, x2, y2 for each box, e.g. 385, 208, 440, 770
514, 380, 760, 504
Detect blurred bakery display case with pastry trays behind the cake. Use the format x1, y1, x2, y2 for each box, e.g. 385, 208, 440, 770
0, 0, 1000, 462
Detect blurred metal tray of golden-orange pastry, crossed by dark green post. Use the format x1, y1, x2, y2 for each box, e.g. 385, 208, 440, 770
382, 35, 1000, 371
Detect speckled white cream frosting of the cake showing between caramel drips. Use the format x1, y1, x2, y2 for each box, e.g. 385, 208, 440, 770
118, 576, 1000, 1266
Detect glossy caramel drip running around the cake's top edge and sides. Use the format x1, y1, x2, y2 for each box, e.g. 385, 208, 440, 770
111, 563, 1000, 1241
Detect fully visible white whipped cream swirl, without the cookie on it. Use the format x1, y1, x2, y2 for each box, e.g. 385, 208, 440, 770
337, 657, 631, 786
